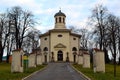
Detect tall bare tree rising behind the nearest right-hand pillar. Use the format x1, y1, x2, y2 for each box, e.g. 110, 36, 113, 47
91, 4, 110, 63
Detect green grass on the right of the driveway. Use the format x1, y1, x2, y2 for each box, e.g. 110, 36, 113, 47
73, 64, 120, 80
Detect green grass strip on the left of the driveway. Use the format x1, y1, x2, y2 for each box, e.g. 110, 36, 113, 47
0, 63, 45, 80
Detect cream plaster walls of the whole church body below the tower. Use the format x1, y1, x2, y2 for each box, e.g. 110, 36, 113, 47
40, 31, 80, 62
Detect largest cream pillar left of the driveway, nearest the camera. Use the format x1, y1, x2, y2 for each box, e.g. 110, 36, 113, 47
11, 49, 24, 72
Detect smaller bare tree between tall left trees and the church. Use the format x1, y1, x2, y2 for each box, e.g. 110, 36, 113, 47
23, 29, 41, 53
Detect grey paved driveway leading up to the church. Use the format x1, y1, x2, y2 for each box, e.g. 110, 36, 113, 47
23, 63, 86, 80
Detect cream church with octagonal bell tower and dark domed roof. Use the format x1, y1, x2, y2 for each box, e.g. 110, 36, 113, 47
40, 10, 81, 63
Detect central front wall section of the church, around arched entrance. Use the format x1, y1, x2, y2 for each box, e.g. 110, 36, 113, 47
50, 32, 70, 61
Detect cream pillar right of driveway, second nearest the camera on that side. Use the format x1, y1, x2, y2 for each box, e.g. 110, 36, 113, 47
83, 53, 90, 68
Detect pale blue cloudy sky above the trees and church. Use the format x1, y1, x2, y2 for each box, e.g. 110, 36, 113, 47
0, 0, 120, 32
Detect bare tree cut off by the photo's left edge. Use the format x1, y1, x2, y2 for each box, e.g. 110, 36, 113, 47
0, 14, 9, 62
